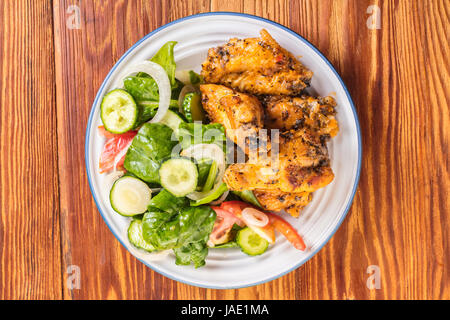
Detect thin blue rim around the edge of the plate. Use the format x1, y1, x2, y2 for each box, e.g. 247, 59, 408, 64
85, 11, 362, 289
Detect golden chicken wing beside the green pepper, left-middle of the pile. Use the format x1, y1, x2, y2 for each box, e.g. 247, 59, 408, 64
200, 84, 270, 153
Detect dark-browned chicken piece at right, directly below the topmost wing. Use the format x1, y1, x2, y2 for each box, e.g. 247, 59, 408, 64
263, 95, 339, 139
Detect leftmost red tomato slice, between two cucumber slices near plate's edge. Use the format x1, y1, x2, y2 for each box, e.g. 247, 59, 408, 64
99, 127, 137, 173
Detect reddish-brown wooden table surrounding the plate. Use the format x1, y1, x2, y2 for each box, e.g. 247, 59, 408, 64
0, 0, 450, 299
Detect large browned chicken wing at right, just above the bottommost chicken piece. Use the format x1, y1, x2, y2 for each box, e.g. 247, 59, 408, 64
224, 128, 334, 193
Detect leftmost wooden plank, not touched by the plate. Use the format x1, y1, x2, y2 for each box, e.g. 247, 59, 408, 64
0, 0, 61, 300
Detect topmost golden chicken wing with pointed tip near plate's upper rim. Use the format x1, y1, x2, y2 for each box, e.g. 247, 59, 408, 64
202, 29, 313, 95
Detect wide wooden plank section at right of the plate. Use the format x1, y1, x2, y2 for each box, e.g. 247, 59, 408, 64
290, 1, 450, 299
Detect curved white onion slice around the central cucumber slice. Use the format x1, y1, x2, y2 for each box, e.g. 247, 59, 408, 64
181, 143, 225, 200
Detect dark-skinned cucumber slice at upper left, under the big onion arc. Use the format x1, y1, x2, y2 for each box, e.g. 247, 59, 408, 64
100, 89, 139, 134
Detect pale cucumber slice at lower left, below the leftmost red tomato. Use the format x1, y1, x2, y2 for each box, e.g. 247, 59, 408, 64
109, 176, 152, 217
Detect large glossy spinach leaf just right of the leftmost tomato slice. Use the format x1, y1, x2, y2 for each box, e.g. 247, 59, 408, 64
124, 123, 177, 183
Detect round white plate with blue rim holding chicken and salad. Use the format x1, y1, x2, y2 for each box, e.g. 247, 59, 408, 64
86, 12, 361, 288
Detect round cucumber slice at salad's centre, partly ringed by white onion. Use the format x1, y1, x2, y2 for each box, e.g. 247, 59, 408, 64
159, 158, 198, 197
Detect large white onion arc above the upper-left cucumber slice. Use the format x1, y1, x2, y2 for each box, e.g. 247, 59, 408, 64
113, 61, 172, 123
